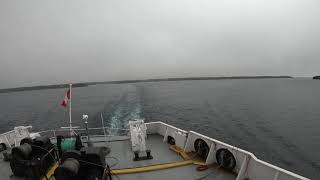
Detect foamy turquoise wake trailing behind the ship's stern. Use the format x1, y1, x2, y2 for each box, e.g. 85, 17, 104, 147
103, 85, 142, 135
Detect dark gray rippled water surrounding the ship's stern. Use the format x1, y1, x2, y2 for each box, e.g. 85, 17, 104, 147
0, 79, 320, 179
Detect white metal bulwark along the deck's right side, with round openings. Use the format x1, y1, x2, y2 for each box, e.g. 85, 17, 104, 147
146, 122, 309, 180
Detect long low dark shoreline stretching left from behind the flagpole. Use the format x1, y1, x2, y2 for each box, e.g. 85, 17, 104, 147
0, 76, 293, 93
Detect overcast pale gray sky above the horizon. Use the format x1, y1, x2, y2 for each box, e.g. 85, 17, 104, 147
0, 0, 320, 88
